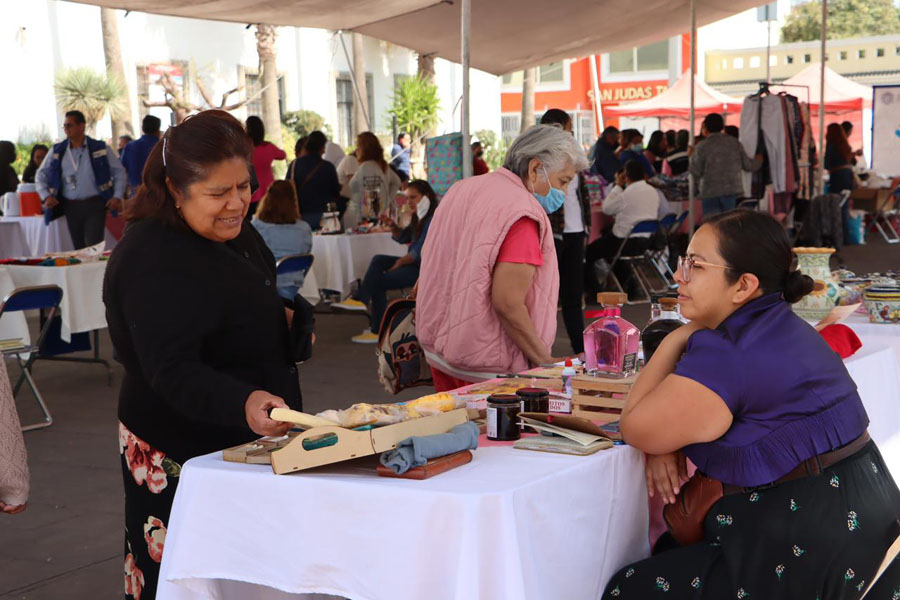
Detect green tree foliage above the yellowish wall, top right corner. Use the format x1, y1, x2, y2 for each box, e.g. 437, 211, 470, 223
781, 0, 900, 43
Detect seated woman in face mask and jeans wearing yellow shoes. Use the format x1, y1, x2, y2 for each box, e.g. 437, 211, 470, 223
332, 179, 438, 344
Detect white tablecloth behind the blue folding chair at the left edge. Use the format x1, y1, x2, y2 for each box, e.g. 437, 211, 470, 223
0, 261, 106, 342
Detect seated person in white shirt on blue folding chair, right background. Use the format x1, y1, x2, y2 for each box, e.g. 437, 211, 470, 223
585, 160, 660, 291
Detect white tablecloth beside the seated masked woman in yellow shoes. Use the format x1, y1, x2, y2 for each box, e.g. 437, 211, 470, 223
312, 233, 407, 296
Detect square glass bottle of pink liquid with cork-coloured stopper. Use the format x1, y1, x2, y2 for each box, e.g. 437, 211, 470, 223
584, 292, 641, 378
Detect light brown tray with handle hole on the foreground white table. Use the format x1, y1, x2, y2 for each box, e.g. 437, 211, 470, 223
222, 408, 468, 475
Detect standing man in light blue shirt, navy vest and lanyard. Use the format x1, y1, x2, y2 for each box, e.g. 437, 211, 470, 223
34, 110, 127, 250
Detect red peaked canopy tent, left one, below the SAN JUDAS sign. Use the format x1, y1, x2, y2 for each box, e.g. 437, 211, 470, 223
604, 70, 743, 119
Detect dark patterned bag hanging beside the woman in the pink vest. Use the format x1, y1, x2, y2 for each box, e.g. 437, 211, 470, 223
375, 298, 432, 394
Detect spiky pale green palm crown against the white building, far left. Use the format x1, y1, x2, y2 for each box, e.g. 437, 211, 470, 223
53, 67, 128, 135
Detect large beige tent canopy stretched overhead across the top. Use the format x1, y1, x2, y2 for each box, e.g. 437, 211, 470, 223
70, 0, 764, 75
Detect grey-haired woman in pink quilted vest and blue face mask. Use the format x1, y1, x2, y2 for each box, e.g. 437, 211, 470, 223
416, 125, 587, 391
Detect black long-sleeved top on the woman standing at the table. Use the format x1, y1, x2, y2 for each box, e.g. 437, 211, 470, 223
103, 219, 301, 462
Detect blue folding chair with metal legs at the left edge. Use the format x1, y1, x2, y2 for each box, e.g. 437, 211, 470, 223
0, 285, 62, 431
